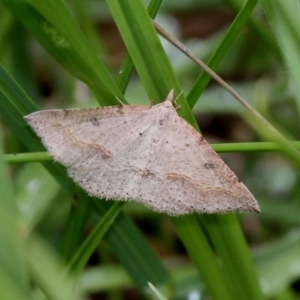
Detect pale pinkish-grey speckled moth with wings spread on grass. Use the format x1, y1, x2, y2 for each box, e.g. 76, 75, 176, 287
25, 91, 260, 215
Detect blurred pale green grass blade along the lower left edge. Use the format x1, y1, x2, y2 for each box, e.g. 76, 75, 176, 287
0, 126, 31, 299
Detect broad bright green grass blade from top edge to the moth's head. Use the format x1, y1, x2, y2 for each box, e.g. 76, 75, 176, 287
107, 0, 197, 127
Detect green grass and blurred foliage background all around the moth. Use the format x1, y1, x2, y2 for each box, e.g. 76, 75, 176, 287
0, 0, 300, 300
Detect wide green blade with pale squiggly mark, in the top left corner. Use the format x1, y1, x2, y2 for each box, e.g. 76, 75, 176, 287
2, 0, 124, 105
